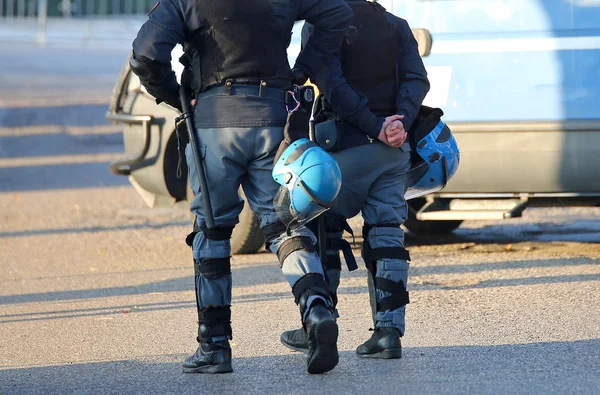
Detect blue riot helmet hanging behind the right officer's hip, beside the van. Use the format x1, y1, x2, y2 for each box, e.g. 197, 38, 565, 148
404, 107, 460, 200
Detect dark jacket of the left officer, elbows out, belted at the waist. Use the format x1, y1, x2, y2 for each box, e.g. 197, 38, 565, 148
130, 0, 352, 128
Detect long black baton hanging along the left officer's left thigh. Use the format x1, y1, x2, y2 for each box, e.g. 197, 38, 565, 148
177, 85, 215, 229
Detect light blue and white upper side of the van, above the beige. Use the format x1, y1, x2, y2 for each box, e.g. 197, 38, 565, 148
392, 0, 600, 122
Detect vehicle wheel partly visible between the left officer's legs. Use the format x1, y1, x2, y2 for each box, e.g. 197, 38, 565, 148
187, 183, 265, 254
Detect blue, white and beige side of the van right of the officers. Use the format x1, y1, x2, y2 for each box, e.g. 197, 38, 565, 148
380, 0, 600, 197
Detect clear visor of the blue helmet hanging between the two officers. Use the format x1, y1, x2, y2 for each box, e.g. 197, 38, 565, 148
273, 181, 329, 230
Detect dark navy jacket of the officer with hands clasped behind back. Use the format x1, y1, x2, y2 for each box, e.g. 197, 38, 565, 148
302, 0, 429, 149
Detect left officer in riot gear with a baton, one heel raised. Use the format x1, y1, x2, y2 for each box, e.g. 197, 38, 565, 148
130, 0, 352, 373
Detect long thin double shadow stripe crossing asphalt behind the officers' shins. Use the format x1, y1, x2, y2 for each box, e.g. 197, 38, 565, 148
0, 258, 600, 323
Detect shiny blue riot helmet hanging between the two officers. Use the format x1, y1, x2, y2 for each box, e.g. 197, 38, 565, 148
273, 138, 342, 231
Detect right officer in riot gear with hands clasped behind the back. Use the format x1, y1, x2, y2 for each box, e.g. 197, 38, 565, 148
281, 0, 429, 358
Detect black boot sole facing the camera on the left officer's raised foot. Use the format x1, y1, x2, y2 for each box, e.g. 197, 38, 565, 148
307, 320, 339, 374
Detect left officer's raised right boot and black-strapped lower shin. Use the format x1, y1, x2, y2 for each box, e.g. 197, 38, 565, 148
292, 273, 339, 374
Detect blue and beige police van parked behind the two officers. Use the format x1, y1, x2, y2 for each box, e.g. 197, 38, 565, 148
107, 0, 600, 253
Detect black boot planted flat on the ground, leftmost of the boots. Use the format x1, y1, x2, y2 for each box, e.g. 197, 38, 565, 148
183, 340, 233, 373
